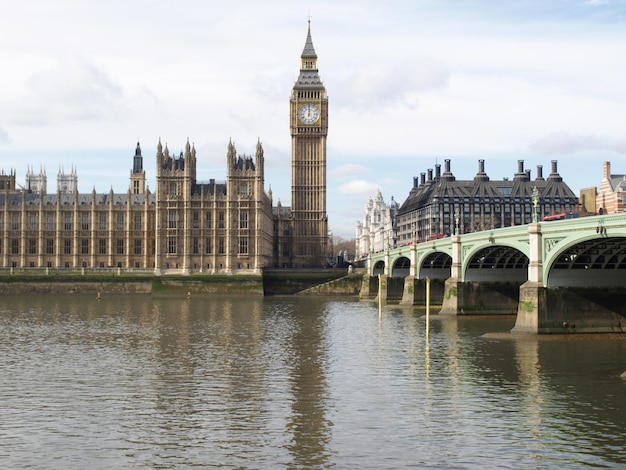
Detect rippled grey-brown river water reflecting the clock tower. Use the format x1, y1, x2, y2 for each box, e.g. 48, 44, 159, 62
0, 296, 626, 469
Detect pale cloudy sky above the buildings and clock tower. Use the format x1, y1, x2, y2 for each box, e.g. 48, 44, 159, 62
0, 0, 626, 238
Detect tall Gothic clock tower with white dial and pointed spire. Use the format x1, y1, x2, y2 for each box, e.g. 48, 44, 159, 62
289, 20, 328, 267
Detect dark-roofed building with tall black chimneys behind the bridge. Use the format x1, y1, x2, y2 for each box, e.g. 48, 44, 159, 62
397, 160, 578, 245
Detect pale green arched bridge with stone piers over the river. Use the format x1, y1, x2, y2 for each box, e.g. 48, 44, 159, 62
362, 214, 626, 333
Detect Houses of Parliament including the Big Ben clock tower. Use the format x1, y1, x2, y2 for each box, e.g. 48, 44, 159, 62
0, 22, 328, 274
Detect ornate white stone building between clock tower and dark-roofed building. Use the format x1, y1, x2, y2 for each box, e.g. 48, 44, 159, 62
355, 190, 399, 259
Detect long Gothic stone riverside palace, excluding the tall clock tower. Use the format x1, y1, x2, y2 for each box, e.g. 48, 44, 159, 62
0, 142, 273, 274
